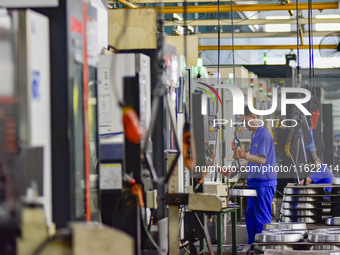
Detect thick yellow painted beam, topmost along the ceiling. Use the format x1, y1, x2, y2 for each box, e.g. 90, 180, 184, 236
123, 2, 338, 14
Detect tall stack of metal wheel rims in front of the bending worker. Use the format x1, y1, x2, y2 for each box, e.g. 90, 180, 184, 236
280, 184, 332, 223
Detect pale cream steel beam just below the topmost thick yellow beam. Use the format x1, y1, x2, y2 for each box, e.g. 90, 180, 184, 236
164, 18, 339, 27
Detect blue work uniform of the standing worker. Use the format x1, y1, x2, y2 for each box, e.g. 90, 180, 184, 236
246, 127, 277, 244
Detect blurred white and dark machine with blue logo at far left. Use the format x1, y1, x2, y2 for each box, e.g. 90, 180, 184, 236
0, 7, 52, 255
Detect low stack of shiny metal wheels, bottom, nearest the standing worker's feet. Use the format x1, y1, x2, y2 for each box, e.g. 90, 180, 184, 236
254, 222, 308, 254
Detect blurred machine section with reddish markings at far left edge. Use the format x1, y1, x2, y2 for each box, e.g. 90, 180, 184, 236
0, 16, 20, 255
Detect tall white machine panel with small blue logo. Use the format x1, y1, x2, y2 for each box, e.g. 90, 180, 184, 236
14, 10, 52, 224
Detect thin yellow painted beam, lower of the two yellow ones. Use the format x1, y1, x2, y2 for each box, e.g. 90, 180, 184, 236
198, 45, 337, 50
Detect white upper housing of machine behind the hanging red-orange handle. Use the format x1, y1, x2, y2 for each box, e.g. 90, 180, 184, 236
98, 53, 151, 134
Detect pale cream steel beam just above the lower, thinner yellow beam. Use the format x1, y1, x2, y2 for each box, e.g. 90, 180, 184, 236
196, 31, 334, 39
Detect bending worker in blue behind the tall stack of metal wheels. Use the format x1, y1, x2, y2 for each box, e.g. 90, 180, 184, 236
300, 153, 334, 192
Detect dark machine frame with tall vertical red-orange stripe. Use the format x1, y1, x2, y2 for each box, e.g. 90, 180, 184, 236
37, 0, 99, 228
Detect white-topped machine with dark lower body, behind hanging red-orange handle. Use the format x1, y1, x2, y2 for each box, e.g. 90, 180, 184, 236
98, 52, 152, 254
